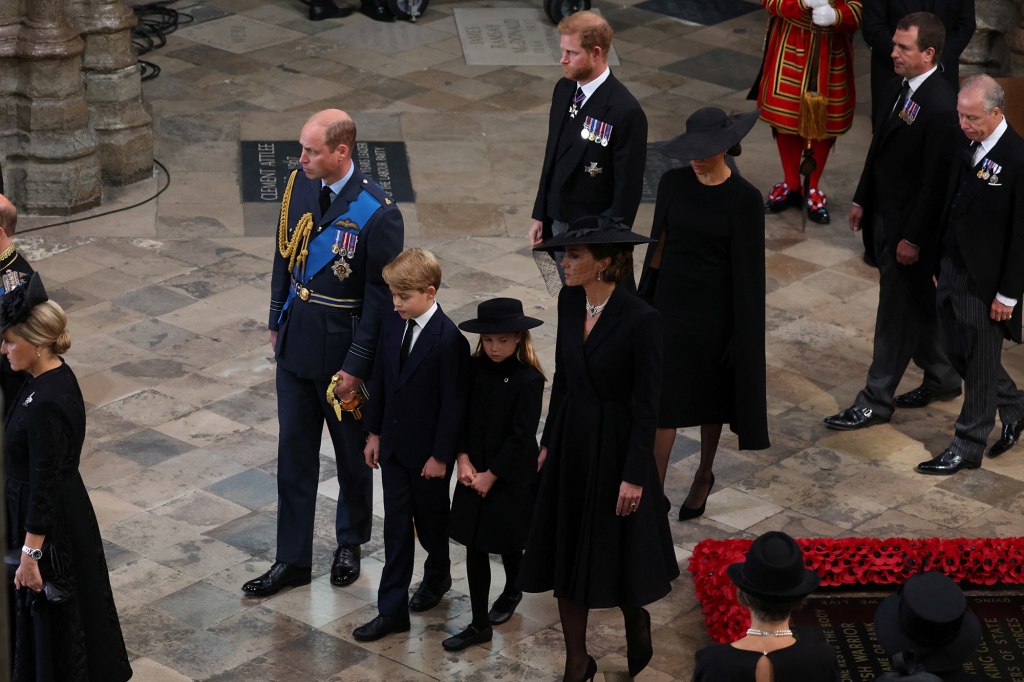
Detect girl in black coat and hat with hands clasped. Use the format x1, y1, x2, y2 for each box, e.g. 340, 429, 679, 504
441, 298, 544, 651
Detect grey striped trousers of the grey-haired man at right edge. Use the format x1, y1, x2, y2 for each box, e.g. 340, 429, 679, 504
936, 256, 1024, 462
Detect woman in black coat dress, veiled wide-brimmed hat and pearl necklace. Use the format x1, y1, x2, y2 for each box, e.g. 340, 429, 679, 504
519, 216, 679, 682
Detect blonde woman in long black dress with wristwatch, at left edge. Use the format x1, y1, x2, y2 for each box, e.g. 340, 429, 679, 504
0, 273, 132, 682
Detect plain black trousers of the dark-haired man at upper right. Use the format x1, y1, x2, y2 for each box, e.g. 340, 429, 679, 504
854, 219, 961, 417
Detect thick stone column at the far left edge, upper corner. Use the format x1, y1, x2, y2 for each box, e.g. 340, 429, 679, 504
0, 0, 101, 215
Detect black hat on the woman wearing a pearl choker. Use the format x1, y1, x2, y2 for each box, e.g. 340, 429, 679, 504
726, 530, 820, 602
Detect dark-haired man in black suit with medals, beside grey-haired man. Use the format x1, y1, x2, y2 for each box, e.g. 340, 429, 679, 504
824, 12, 967, 430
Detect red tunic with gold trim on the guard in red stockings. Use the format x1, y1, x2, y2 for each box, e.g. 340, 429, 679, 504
758, 0, 862, 137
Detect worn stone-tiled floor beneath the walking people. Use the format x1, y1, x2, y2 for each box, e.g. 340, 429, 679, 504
17, 0, 1024, 682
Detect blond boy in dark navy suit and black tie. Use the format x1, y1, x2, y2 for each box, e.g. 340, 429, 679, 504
352, 249, 469, 642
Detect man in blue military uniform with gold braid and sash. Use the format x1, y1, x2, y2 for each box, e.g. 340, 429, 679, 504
242, 110, 404, 596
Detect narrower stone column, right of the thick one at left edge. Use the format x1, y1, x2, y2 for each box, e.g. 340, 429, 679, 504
68, 0, 153, 185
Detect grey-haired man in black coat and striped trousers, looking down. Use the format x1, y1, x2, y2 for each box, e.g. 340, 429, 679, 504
916, 76, 1024, 475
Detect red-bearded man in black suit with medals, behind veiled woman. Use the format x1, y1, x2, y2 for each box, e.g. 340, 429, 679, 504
529, 11, 647, 260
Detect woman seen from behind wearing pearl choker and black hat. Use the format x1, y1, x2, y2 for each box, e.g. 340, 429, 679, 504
692, 530, 840, 682
